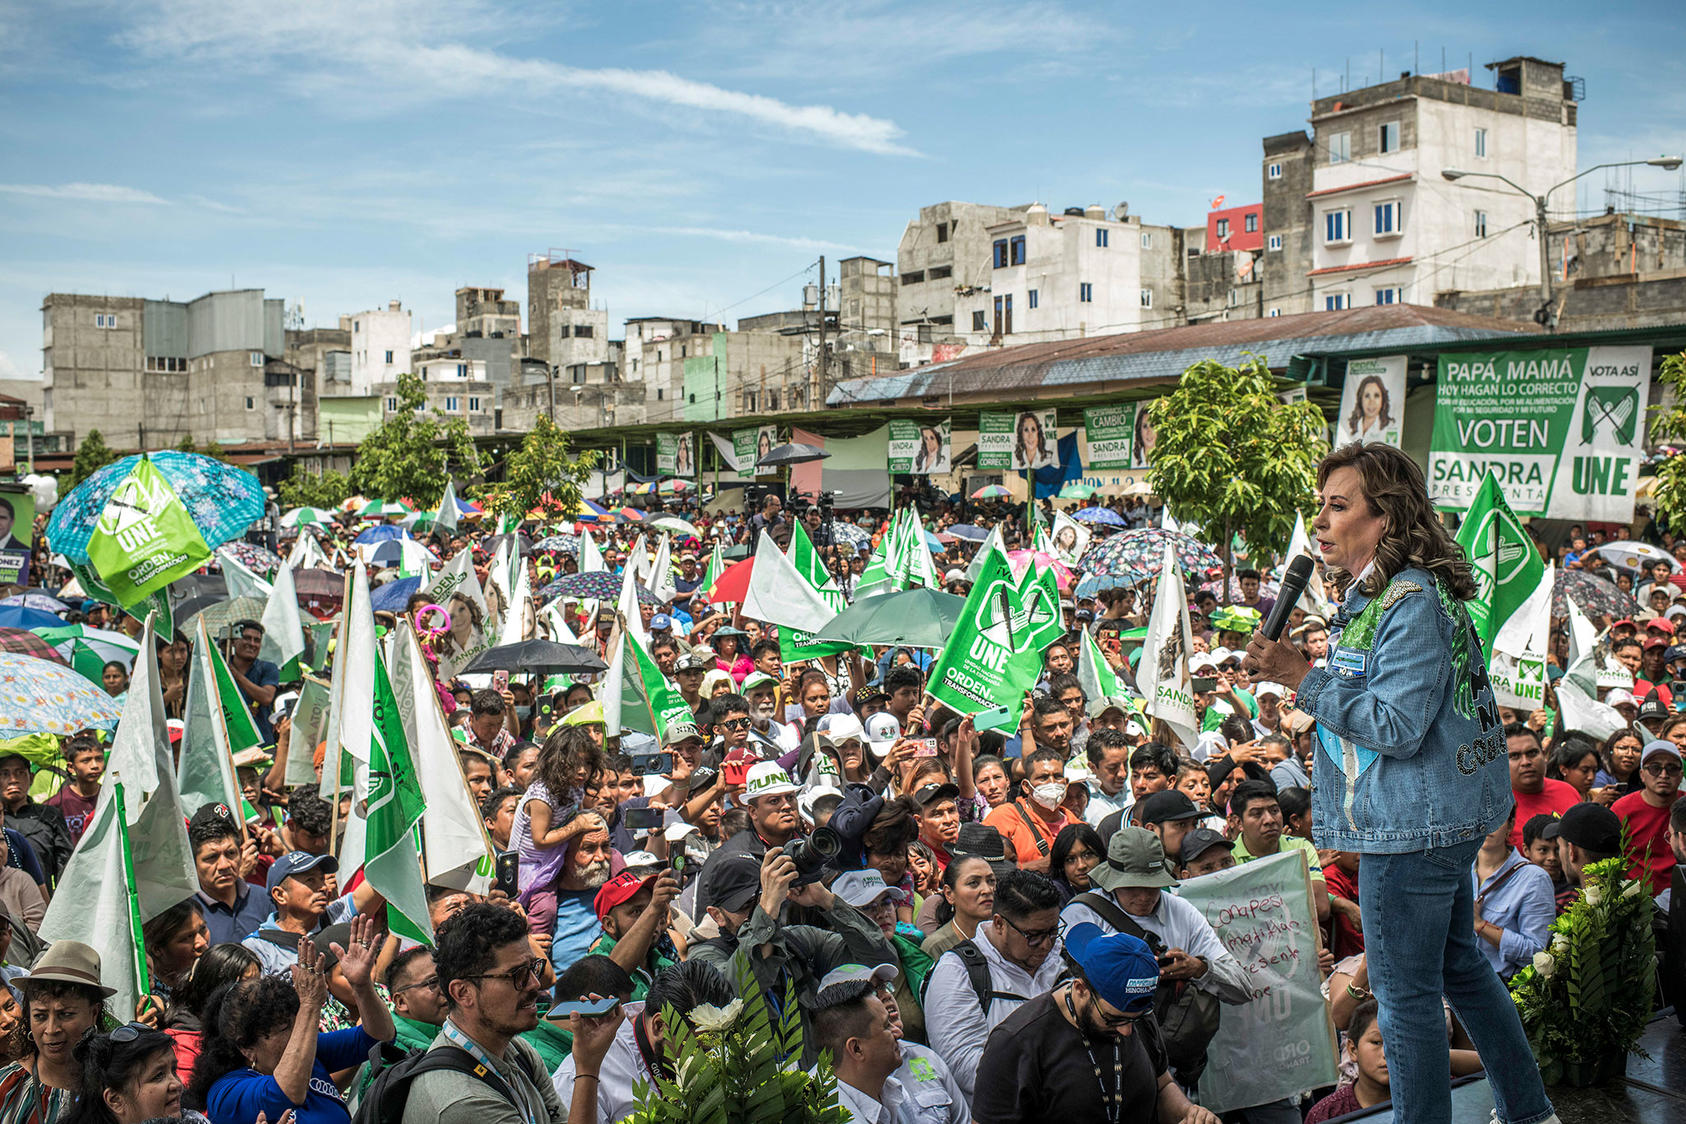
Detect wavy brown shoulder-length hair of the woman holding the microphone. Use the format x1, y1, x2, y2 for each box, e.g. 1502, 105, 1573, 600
1317, 445, 1477, 602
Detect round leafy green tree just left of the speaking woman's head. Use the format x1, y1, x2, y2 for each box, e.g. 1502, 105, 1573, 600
1148, 354, 1329, 580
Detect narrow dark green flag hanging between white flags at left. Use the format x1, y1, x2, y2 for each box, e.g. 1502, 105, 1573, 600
362, 654, 433, 944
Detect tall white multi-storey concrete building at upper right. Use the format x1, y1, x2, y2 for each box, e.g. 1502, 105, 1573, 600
1288, 57, 1578, 315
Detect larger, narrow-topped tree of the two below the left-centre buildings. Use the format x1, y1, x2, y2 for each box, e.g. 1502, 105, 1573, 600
351, 374, 481, 507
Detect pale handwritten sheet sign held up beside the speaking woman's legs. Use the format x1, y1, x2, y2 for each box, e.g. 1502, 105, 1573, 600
1177, 851, 1339, 1114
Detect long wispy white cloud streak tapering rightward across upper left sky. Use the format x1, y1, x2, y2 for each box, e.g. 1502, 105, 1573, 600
120, 0, 912, 155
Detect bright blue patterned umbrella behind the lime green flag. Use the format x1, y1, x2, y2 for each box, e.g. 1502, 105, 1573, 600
47, 448, 263, 566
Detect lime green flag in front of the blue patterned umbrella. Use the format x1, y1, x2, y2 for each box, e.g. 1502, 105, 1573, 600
88, 457, 211, 608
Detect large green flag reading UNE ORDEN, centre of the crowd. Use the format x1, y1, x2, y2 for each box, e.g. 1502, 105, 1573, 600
927, 553, 1060, 730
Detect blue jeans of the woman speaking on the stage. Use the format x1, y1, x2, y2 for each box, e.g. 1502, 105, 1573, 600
1359, 839, 1551, 1124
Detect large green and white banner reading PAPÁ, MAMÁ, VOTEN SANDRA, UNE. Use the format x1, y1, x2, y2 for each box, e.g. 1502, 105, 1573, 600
1428, 347, 1651, 522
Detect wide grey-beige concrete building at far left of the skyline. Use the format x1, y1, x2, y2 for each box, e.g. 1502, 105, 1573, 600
42, 288, 306, 448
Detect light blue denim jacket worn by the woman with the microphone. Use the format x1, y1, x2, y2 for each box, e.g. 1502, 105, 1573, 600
1295, 568, 1512, 854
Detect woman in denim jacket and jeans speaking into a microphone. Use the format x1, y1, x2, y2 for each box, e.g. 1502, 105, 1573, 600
1248, 445, 1556, 1124
